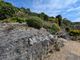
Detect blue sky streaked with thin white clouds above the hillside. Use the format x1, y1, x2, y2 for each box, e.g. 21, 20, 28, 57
4, 0, 80, 22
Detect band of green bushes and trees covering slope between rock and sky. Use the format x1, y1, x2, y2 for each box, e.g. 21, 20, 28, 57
0, 0, 80, 39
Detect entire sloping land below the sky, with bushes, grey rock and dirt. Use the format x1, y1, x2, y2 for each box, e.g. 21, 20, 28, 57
0, 0, 80, 60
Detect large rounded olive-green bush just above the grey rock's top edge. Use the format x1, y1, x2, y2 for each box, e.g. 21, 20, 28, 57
26, 17, 43, 29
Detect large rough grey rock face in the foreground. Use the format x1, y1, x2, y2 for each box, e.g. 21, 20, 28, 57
0, 28, 62, 60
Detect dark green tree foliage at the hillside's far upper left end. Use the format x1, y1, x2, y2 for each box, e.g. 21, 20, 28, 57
0, 1, 15, 20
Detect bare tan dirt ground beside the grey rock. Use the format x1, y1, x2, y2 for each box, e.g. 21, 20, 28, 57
45, 41, 80, 60
